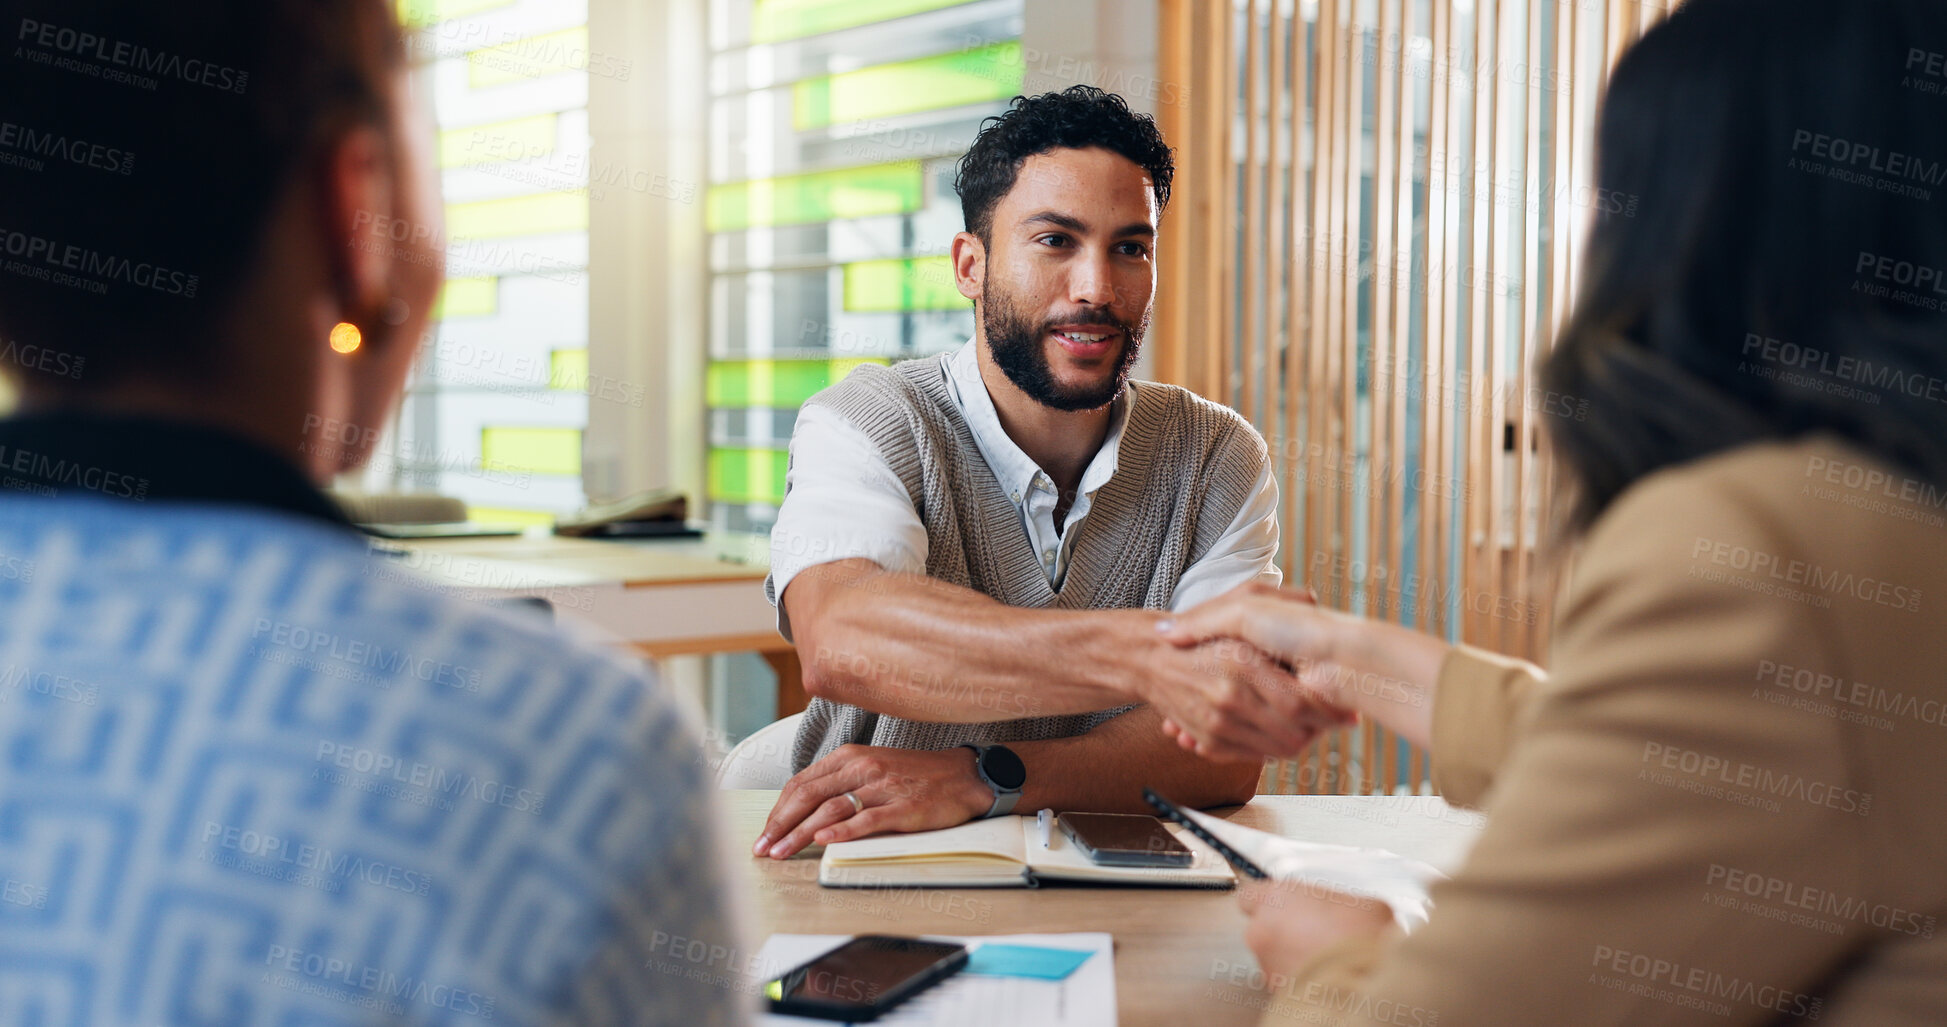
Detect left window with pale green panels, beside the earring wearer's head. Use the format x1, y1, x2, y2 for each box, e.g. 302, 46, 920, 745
366, 0, 609, 522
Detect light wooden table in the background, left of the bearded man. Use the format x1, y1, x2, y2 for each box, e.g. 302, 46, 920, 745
382, 532, 806, 717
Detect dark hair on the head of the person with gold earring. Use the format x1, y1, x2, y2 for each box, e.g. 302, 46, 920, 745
0, 0, 403, 388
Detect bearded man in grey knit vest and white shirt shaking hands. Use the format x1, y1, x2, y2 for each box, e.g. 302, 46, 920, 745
753, 86, 1330, 859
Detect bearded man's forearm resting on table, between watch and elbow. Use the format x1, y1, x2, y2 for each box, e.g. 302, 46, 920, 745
1007, 705, 1264, 813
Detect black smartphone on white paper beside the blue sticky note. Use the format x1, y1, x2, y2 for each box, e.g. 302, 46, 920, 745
763, 933, 968, 1021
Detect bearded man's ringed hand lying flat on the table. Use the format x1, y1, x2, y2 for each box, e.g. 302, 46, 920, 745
752, 744, 993, 859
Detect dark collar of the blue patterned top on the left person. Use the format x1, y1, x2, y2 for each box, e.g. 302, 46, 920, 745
0, 411, 358, 532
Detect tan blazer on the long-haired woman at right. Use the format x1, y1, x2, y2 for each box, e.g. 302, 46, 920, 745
1266, 437, 1947, 1027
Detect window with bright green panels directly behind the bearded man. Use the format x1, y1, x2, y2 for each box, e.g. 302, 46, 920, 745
705, 0, 1024, 532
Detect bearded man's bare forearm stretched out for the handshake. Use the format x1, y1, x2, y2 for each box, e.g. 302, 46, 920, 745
781, 559, 1166, 724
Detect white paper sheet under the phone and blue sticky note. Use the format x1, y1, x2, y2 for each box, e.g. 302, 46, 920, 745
755, 933, 1116, 1027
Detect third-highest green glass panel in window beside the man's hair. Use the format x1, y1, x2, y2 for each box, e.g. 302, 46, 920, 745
703, 160, 927, 232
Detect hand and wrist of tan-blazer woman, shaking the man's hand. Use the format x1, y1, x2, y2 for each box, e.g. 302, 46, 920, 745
1162, 585, 1452, 748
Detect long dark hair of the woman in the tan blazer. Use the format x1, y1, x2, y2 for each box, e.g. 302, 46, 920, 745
1540, 0, 1947, 532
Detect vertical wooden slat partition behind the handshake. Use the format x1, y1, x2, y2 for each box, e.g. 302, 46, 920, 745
1149, 0, 1672, 791
